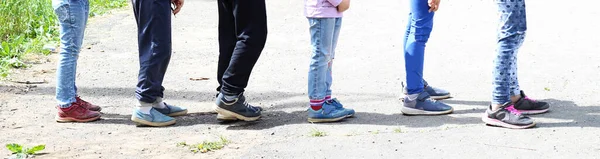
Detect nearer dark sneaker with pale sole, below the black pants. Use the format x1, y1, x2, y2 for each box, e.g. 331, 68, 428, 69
215, 93, 262, 121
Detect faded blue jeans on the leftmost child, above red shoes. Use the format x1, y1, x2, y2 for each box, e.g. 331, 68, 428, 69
52, 0, 89, 107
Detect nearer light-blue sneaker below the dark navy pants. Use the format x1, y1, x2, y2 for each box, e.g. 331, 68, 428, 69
131, 108, 175, 127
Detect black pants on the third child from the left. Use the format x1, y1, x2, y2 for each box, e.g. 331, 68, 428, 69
217, 0, 267, 95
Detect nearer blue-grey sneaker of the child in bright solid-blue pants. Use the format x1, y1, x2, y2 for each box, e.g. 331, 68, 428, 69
400, 92, 454, 115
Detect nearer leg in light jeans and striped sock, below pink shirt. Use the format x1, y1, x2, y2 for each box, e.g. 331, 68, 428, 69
308, 18, 335, 110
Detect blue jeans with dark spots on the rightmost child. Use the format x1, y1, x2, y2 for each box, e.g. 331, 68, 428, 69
492, 0, 527, 104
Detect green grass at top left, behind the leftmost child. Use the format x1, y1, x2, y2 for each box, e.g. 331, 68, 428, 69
0, 0, 128, 78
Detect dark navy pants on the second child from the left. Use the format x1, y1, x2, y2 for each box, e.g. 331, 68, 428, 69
132, 0, 171, 103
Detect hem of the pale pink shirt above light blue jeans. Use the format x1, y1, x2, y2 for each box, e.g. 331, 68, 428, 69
304, 0, 343, 18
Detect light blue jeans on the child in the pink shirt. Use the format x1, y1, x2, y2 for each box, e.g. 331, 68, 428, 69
308, 18, 342, 100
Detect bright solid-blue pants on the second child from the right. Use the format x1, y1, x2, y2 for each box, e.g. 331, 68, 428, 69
404, 0, 434, 94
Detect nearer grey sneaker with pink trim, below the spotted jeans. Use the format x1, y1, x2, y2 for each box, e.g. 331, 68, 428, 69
481, 102, 535, 129
